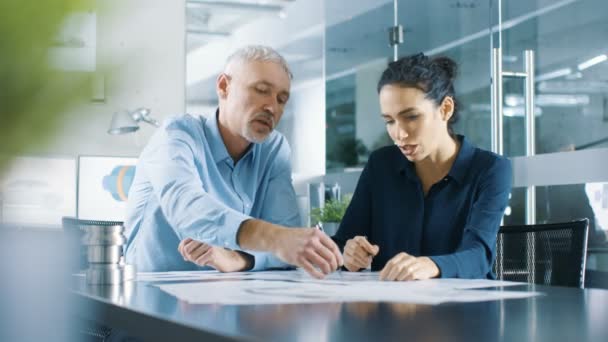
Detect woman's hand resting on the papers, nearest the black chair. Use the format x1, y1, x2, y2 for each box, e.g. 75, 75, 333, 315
380, 252, 439, 281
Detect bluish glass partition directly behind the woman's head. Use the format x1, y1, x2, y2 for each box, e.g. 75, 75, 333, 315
325, 0, 491, 173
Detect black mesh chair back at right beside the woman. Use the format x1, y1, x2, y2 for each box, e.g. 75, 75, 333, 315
494, 219, 589, 288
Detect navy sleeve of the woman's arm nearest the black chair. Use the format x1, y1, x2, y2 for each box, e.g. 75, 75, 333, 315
430, 158, 512, 278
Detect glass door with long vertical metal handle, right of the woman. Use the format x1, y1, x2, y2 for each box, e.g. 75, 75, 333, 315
490, 0, 608, 270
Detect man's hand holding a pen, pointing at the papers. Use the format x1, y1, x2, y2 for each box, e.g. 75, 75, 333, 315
273, 228, 344, 279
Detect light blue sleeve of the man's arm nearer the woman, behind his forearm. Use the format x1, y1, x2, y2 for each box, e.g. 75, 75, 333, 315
245, 138, 302, 271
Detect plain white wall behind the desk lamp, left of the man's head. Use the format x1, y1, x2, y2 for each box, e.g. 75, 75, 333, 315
46, 0, 185, 156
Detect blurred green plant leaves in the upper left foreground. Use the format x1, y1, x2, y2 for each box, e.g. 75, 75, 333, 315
0, 0, 94, 172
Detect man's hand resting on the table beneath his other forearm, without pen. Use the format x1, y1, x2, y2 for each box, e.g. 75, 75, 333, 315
177, 238, 254, 272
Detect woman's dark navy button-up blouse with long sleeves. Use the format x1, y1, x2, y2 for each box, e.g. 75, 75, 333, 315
333, 135, 512, 279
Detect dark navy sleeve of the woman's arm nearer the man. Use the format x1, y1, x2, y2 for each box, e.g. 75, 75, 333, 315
332, 155, 373, 251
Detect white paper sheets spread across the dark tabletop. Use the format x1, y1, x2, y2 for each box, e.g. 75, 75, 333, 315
144, 271, 541, 305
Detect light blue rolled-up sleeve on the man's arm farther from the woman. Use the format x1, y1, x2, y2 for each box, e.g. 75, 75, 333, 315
138, 123, 251, 249
